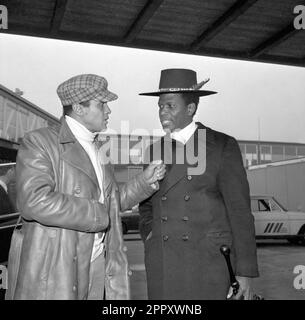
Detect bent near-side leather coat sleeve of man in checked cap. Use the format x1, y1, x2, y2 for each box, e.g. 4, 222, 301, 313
16, 134, 109, 232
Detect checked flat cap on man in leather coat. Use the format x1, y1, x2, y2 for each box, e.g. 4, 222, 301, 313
57, 74, 118, 106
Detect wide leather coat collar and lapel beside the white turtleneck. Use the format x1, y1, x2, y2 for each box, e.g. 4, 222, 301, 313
59, 118, 99, 187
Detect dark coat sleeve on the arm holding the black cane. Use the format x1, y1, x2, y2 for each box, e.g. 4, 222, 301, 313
218, 137, 258, 277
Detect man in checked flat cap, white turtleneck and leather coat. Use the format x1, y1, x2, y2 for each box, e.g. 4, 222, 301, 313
6, 74, 165, 300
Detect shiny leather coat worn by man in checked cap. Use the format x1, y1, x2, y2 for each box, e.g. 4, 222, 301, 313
8, 119, 154, 299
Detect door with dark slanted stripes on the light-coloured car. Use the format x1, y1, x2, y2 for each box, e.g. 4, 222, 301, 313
251, 197, 289, 238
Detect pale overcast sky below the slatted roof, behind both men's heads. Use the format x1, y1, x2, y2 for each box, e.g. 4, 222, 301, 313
0, 34, 305, 143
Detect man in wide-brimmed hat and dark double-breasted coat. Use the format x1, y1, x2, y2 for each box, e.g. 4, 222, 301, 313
139, 69, 258, 300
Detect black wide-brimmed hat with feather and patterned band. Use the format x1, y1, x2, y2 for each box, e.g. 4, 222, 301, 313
140, 69, 217, 96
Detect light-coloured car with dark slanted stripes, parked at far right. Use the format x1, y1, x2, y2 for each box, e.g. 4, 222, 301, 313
251, 195, 305, 245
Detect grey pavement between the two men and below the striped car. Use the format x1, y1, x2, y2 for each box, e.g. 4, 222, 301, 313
124, 233, 305, 300
